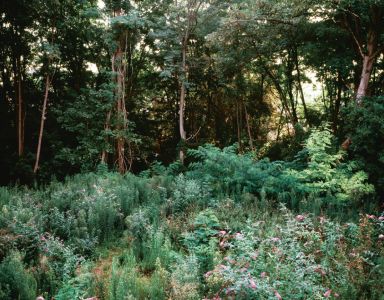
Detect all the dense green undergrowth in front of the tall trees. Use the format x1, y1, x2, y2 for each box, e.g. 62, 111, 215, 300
0, 129, 384, 300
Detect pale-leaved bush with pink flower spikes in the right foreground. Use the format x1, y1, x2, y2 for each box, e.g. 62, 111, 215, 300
205, 208, 383, 299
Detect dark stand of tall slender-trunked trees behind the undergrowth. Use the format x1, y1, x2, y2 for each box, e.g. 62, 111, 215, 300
0, 0, 384, 188
